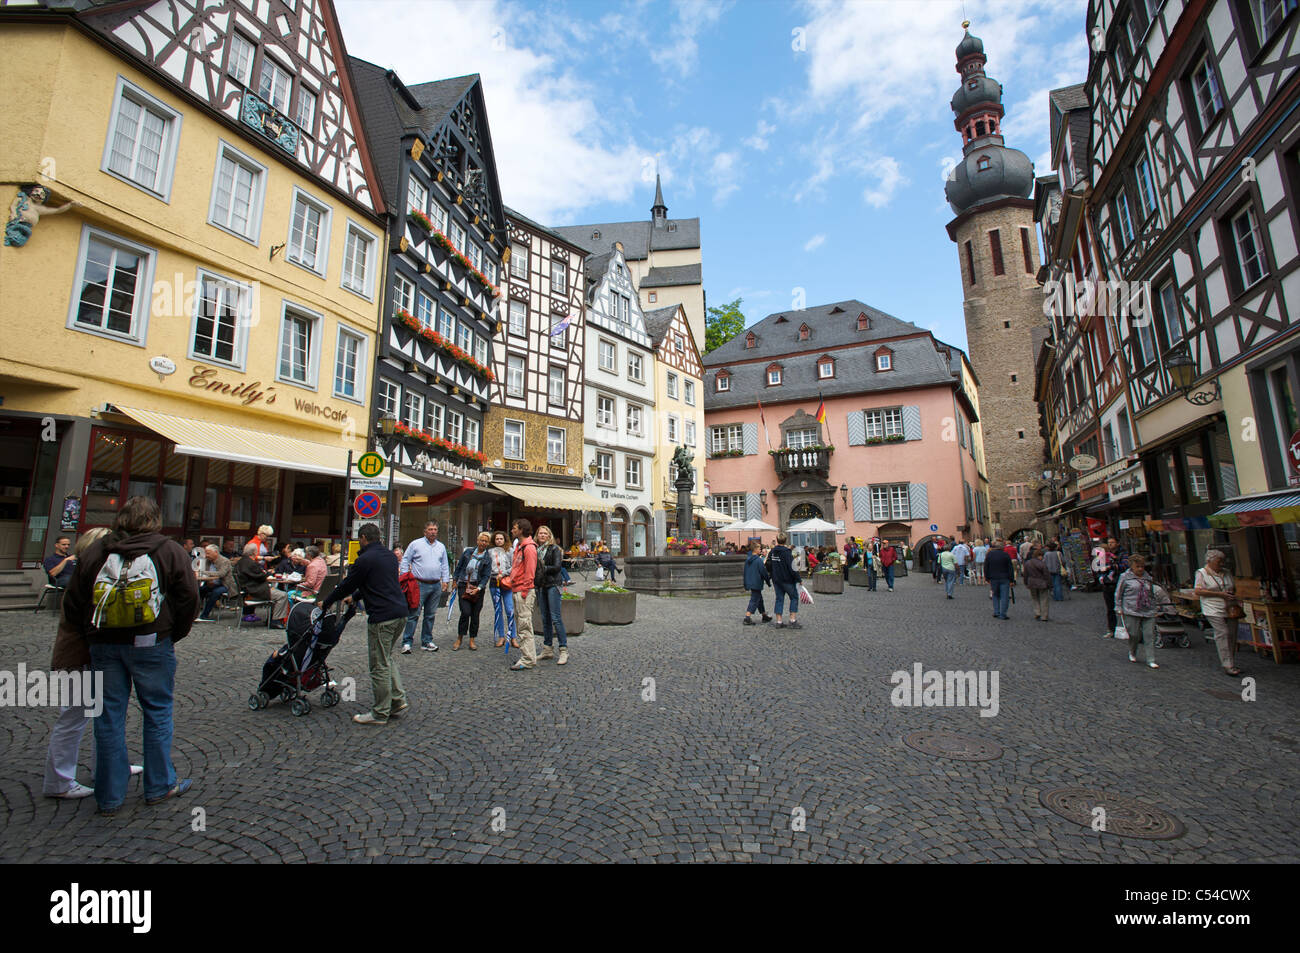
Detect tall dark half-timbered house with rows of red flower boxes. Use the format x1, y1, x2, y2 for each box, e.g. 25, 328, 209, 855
352, 57, 507, 547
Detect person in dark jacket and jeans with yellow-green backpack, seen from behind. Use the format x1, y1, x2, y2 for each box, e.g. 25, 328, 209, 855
64, 497, 199, 814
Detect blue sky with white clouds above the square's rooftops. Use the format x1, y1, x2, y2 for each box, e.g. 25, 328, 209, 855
335, 0, 1088, 347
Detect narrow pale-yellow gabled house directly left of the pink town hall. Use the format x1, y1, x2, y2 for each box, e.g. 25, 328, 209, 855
645, 304, 711, 543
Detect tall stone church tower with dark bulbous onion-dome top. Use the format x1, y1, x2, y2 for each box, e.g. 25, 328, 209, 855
944, 21, 1047, 536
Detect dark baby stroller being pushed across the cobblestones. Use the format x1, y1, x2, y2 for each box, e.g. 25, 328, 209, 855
248, 602, 356, 715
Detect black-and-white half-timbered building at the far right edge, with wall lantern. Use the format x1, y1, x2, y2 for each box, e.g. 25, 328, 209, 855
1087, 0, 1300, 582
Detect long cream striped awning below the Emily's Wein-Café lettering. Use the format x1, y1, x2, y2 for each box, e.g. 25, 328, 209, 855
113, 404, 424, 486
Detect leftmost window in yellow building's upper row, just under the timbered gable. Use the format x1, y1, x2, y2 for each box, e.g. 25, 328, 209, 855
100, 77, 181, 202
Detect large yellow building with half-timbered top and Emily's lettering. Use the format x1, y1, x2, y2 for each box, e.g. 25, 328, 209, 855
0, 0, 395, 568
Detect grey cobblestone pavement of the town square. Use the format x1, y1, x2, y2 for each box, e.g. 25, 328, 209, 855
0, 575, 1300, 862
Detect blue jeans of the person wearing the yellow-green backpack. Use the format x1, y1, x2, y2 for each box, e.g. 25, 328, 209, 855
90, 638, 176, 810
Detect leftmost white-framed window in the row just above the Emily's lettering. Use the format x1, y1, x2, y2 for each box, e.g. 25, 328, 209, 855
68, 226, 153, 345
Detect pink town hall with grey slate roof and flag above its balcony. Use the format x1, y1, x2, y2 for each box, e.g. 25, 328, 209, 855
703, 300, 989, 550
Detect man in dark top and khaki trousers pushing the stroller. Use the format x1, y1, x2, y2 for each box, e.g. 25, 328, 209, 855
312, 523, 407, 724
